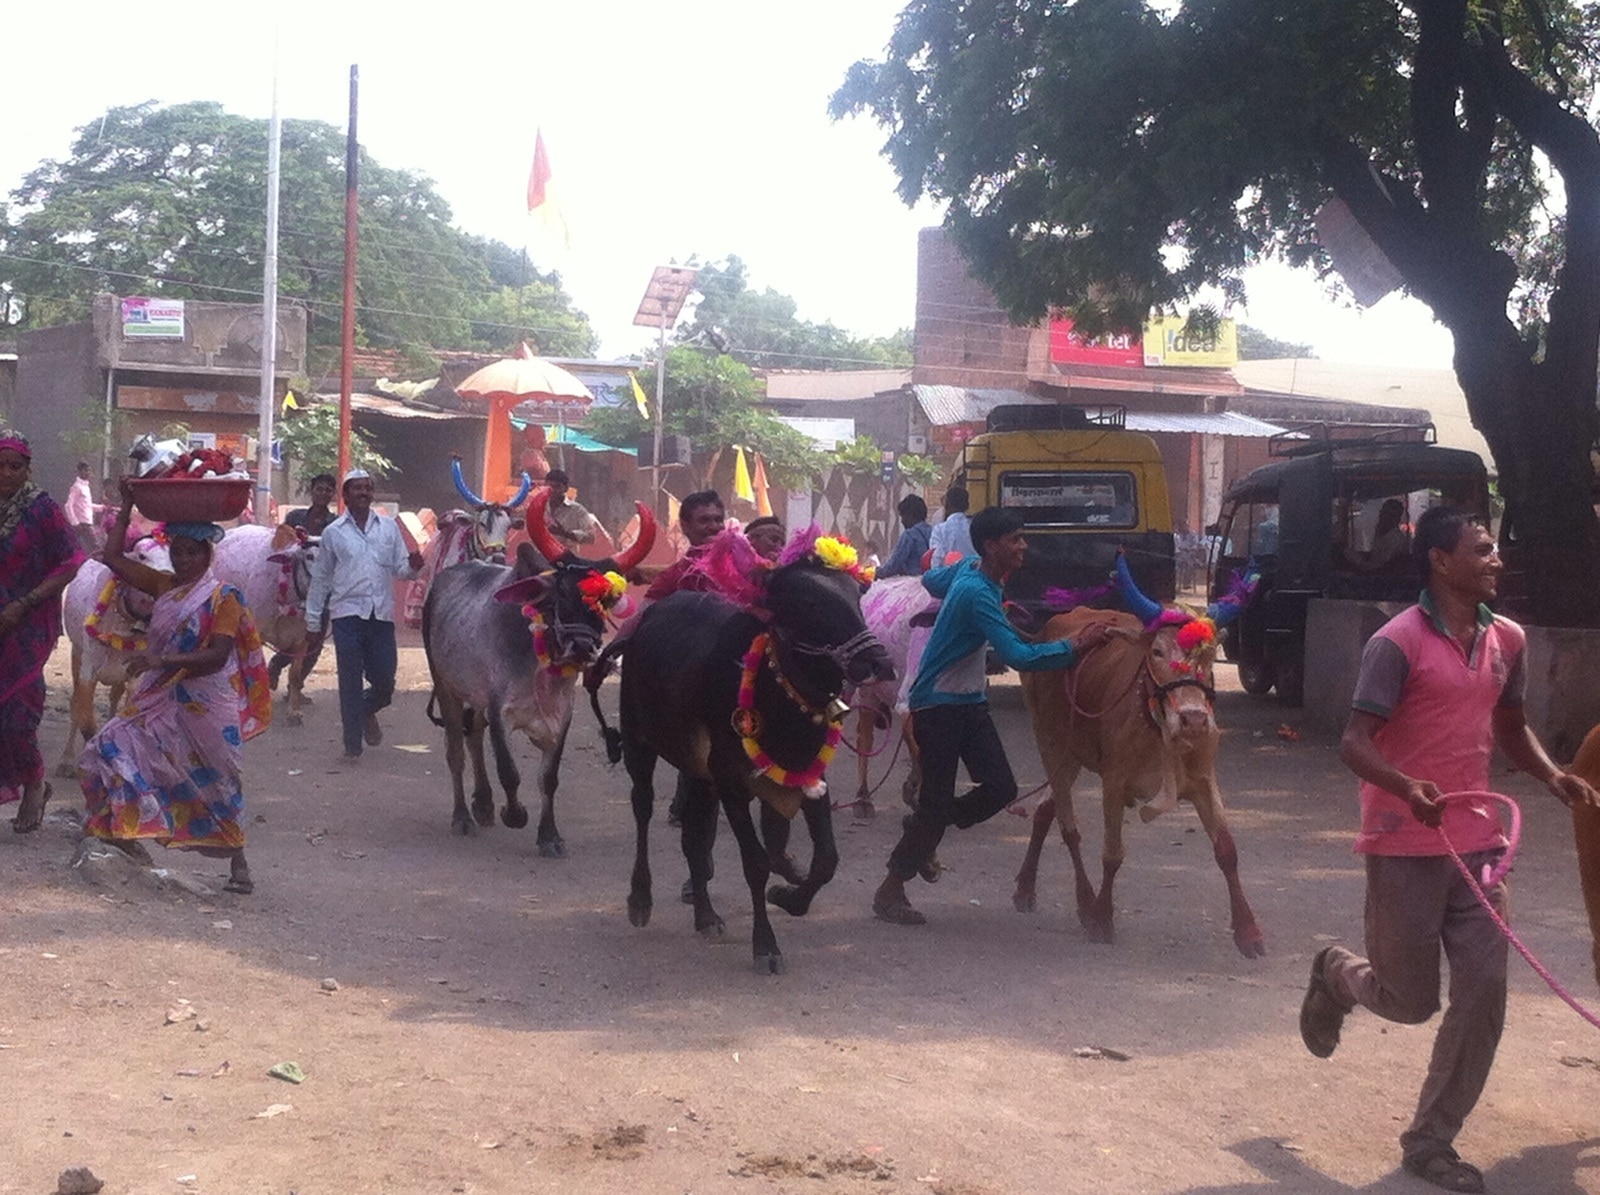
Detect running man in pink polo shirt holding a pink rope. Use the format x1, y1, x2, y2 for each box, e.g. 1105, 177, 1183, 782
1301, 507, 1597, 1192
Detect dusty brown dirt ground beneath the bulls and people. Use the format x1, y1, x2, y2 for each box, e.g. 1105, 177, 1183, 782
0, 636, 1600, 1195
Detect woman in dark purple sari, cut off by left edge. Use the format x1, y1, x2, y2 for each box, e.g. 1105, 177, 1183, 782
0, 429, 83, 833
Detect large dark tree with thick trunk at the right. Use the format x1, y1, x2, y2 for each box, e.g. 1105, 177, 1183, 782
832, 0, 1600, 625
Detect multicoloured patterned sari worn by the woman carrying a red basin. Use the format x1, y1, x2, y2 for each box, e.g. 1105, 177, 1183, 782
78, 570, 272, 849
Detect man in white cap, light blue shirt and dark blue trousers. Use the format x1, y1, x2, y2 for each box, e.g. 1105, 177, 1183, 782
306, 469, 422, 761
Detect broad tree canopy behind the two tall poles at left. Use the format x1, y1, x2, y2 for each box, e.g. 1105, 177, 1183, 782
0, 102, 597, 357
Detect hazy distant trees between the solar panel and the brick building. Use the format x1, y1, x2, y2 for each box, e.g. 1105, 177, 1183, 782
677, 256, 912, 370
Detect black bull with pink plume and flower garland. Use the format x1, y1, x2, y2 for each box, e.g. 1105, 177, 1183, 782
595, 558, 893, 973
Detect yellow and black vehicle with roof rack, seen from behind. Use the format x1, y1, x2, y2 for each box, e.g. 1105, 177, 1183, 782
955, 405, 1176, 625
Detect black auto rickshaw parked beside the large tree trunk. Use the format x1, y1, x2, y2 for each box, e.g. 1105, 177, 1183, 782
1206, 426, 1490, 705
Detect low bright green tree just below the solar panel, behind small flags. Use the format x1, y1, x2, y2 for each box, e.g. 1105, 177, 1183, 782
586, 346, 827, 488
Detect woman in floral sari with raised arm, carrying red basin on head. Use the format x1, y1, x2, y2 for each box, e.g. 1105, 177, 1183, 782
78, 482, 272, 893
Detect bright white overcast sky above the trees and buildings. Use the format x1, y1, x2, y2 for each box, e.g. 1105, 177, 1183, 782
0, 0, 1450, 368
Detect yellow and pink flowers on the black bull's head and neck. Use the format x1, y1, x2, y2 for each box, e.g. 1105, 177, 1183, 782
731, 525, 874, 797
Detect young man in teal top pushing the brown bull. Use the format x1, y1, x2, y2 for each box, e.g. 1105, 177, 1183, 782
872, 507, 1109, 925
